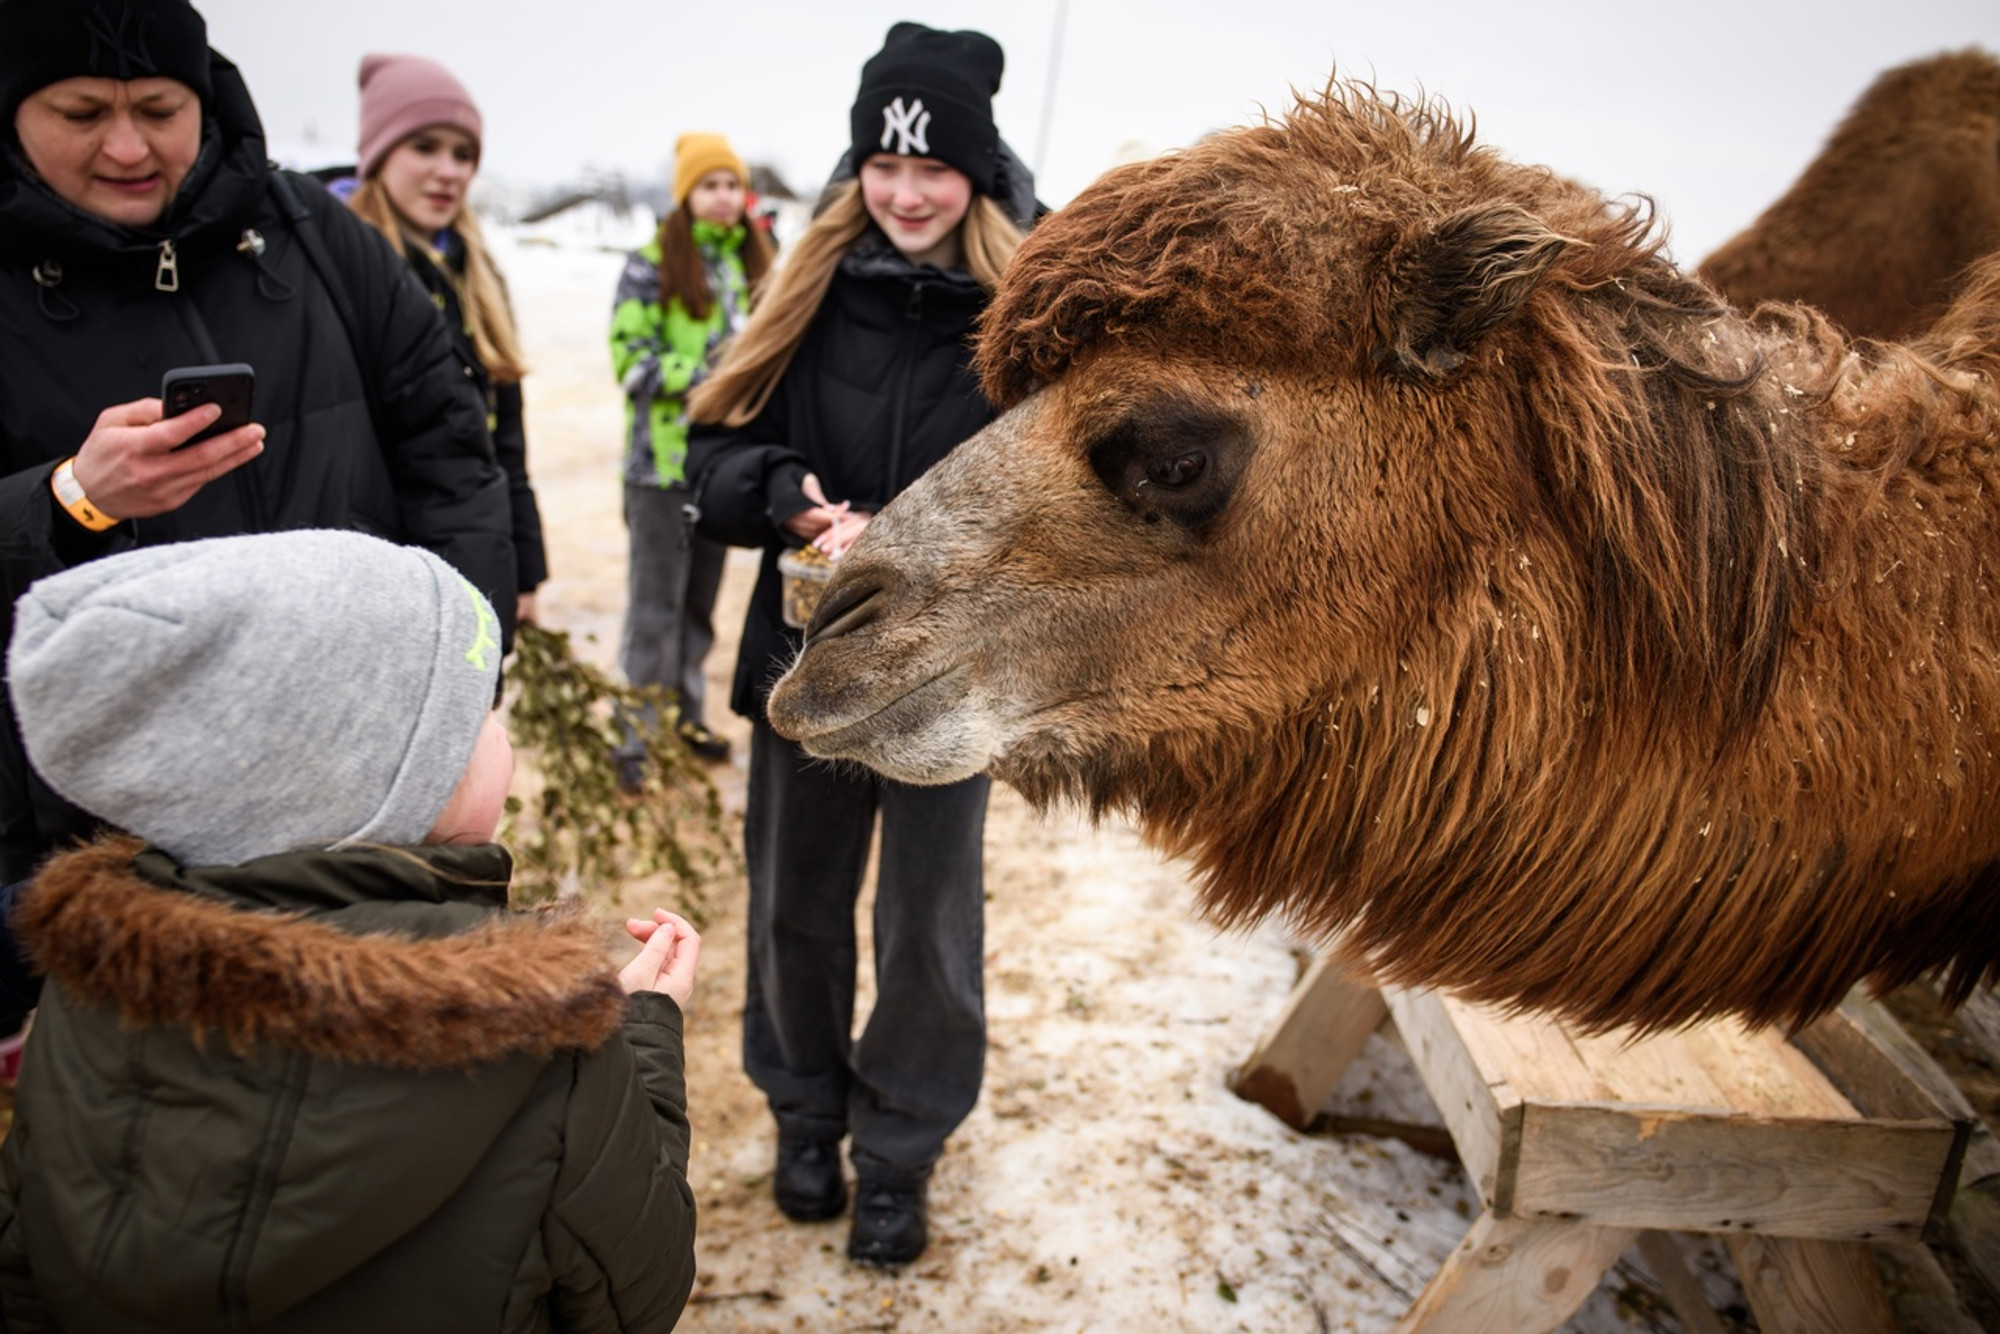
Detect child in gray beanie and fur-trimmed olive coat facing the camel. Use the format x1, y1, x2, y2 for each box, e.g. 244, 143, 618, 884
0, 532, 700, 1330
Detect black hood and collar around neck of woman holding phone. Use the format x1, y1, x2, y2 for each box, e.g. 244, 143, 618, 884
0, 52, 270, 260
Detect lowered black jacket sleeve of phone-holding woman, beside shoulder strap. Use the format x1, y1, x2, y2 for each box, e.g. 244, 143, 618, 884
294, 182, 518, 642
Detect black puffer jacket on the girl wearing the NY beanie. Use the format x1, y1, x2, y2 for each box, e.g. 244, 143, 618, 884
688, 235, 994, 718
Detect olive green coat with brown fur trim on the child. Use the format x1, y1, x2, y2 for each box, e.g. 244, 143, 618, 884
0, 842, 694, 1334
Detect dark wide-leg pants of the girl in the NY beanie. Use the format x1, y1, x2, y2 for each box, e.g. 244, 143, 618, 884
744, 722, 992, 1186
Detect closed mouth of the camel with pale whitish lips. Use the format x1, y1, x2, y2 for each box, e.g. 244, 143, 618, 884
770, 662, 986, 782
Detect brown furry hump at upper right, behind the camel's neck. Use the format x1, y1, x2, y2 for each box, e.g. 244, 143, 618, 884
1698, 50, 2000, 340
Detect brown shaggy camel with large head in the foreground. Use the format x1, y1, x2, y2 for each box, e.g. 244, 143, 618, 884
770, 82, 2000, 1032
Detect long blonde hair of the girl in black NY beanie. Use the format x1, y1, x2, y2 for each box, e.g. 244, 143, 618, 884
688, 180, 1020, 426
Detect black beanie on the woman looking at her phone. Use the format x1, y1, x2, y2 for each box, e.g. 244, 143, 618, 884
0, 0, 210, 126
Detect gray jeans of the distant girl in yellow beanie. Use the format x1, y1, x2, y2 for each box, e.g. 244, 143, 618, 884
618, 482, 728, 722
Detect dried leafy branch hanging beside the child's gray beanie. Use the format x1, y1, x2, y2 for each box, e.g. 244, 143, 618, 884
502, 624, 736, 926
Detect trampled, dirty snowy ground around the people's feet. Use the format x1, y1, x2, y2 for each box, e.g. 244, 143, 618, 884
502, 238, 1728, 1334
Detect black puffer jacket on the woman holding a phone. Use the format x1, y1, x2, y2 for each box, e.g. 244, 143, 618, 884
0, 56, 516, 882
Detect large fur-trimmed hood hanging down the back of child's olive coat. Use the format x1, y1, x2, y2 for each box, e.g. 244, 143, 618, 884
16, 840, 626, 1328
